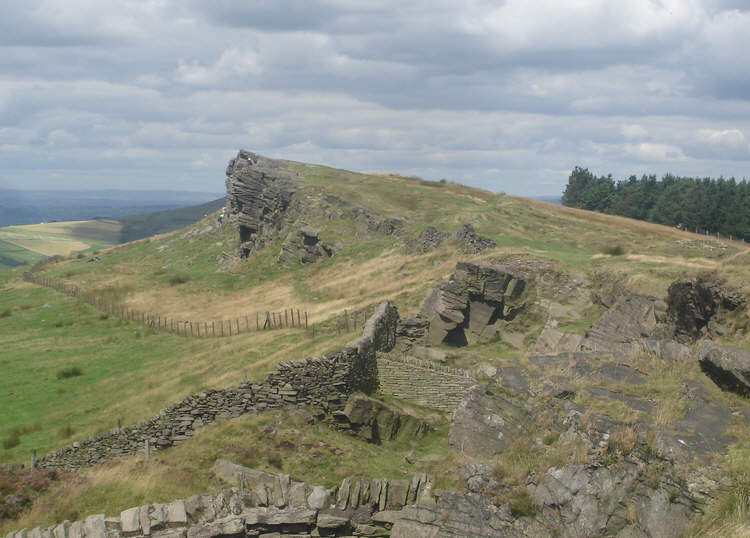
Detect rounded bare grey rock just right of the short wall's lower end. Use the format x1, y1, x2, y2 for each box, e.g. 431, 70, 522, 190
448, 385, 529, 457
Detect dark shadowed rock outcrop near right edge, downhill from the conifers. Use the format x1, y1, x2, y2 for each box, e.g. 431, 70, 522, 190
667, 277, 745, 343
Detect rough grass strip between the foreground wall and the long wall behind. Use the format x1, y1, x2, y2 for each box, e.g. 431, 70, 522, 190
0, 411, 446, 534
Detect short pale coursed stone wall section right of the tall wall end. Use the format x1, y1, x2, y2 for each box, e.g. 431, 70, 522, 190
377, 353, 477, 411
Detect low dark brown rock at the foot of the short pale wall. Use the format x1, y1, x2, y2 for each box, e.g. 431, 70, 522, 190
333, 394, 429, 443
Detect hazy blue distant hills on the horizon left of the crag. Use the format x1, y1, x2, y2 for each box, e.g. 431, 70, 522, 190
0, 189, 222, 226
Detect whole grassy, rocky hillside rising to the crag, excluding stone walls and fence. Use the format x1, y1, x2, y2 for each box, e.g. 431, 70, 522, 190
0, 152, 750, 536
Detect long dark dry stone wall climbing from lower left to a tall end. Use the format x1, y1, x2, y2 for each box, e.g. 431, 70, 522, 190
37, 302, 398, 470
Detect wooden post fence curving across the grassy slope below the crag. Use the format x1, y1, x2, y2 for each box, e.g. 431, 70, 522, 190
23, 271, 314, 338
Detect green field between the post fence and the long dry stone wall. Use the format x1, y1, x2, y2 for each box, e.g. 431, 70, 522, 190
0, 285, 346, 463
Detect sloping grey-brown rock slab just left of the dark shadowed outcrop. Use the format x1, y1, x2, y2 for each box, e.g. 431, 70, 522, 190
581, 294, 667, 354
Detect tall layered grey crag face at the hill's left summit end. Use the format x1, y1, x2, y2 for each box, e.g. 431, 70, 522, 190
226, 150, 295, 256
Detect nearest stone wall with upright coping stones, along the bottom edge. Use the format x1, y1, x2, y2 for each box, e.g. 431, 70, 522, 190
6, 460, 434, 538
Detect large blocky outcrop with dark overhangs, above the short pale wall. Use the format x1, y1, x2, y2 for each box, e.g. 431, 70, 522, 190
419, 262, 526, 346
